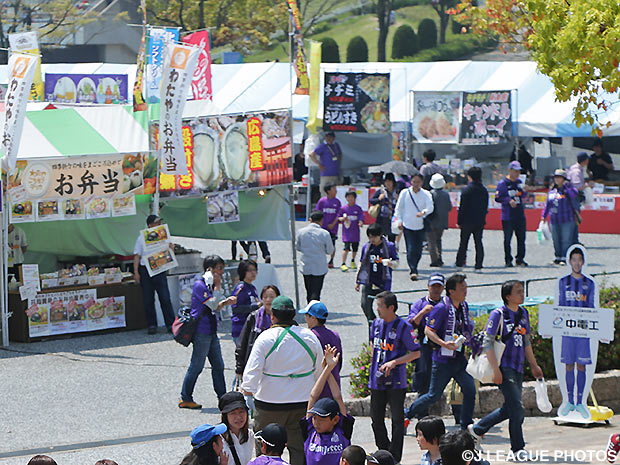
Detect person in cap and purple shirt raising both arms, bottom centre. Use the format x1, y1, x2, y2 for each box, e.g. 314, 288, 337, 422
301, 345, 355, 465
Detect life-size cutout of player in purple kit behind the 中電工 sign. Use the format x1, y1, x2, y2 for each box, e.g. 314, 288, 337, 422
558, 246, 598, 419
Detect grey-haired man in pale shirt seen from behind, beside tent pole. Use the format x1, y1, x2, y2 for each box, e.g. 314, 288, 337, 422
295, 211, 334, 303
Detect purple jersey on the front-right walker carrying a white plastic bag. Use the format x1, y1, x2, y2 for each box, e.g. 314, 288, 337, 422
486, 306, 530, 373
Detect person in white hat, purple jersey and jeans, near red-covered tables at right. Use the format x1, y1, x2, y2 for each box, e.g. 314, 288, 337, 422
541, 170, 578, 265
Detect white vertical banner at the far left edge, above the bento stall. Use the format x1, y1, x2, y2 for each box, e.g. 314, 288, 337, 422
2, 53, 38, 170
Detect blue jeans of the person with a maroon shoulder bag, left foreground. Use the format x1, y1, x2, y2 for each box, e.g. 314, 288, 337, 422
181, 332, 226, 402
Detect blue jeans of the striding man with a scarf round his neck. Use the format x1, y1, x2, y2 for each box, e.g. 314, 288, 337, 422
408, 349, 476, 429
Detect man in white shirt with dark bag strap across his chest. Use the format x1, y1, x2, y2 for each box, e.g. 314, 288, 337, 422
394, 173, 435, 281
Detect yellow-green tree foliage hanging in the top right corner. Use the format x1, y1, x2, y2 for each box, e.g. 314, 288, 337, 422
450, 0, 620, 136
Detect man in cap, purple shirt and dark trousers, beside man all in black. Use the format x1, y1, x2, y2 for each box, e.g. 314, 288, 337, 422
495, 160, 527, 267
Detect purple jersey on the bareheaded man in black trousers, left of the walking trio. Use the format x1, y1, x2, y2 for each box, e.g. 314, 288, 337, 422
368, 317, 420, 391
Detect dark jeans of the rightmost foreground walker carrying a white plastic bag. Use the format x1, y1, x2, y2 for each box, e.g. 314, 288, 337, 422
474, 367, 525, 452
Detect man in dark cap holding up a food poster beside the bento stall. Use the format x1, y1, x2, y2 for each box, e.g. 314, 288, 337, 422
133, 215, 174, 334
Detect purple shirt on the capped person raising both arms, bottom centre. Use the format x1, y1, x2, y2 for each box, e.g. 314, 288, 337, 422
301, 414, 355, 465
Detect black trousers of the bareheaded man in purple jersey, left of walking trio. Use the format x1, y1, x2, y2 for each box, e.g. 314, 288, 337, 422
370, 389, 405, 463
